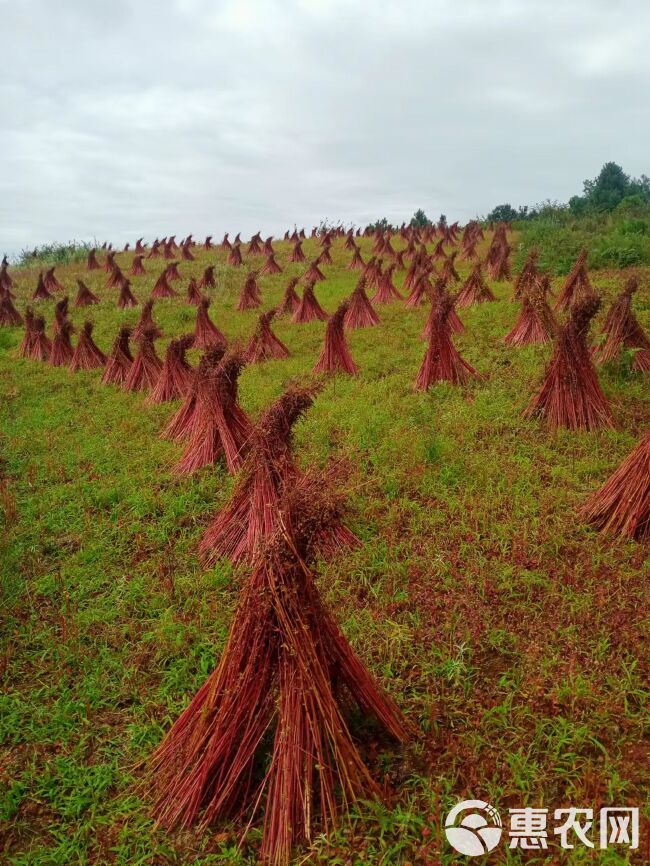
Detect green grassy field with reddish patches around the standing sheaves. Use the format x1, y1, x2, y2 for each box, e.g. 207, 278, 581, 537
0, 233, 650, 866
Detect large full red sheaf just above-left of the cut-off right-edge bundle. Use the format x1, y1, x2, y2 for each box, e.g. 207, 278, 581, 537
524, 295, 612, 430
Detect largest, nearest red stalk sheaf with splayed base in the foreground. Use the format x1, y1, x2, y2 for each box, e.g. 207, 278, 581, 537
153, 496, 407, 866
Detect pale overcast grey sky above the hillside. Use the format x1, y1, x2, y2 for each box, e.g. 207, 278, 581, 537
0, 0, 650, 254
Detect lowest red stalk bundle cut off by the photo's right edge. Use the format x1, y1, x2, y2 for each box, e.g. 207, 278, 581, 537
580, 430, 650, 541
